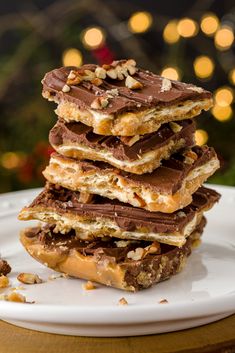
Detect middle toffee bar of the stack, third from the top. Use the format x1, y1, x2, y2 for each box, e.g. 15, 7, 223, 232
43, 146, 219, 213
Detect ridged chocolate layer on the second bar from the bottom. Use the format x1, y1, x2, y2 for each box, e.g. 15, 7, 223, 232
29, 183, 220, 233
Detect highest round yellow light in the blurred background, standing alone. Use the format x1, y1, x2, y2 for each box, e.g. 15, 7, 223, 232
128, 11, 153, 33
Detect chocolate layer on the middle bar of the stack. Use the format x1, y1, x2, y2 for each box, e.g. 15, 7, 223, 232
52, 146, 216, 194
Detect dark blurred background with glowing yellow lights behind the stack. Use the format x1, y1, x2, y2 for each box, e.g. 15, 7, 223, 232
0, 0, 235, 192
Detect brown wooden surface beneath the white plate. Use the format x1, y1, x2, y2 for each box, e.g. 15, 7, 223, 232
0, 315, 235, 353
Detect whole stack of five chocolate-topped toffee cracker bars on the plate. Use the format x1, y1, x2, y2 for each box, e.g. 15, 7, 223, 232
19, 60, 220, 291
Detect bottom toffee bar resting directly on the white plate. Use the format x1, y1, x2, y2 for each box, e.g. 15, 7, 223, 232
21, 218, 206, 291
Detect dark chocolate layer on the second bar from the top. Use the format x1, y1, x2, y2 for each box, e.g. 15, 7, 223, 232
49, 120, 195, 161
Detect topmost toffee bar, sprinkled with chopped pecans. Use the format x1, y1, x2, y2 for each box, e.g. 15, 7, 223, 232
42, 60, 212, 136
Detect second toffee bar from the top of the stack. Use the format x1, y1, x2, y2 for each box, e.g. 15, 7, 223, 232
49, 119, 195, 174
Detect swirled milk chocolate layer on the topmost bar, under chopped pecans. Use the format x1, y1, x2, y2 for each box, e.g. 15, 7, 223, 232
42, 64, 212, 114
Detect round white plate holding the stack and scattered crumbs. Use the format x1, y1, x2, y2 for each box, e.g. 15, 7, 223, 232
0, 186, 235, 337
